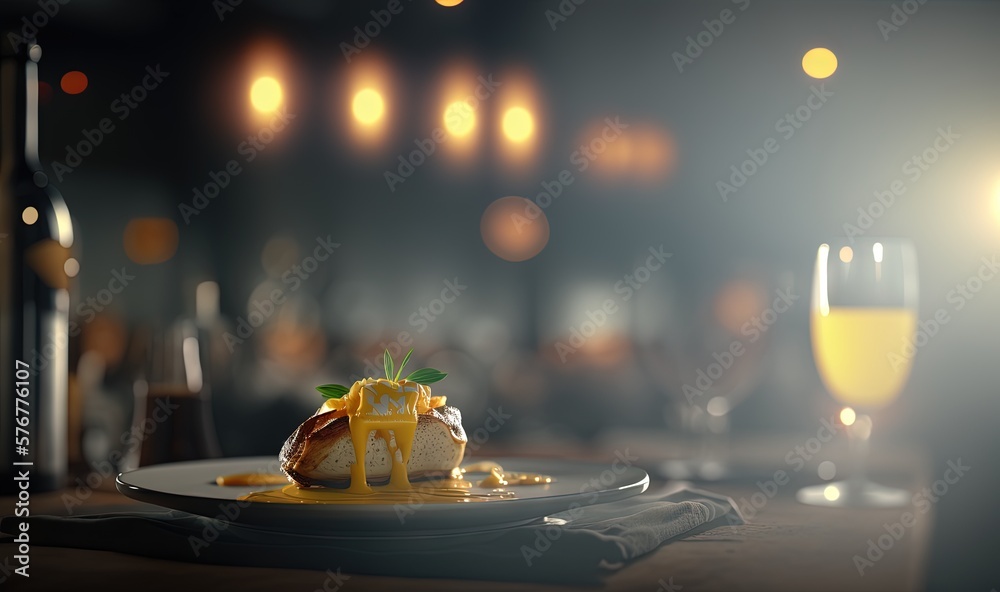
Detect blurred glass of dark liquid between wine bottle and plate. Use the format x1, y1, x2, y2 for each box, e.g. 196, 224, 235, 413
124, 319, 220, 468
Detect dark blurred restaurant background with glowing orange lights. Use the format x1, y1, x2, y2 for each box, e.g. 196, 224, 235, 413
0, 0, 1000, 590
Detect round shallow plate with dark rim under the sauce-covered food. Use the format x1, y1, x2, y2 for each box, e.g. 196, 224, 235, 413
117, 456, 649, 537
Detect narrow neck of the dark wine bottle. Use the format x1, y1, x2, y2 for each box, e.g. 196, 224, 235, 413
0, 37, 41, 173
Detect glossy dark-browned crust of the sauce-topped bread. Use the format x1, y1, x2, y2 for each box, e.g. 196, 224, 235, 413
278, 405, 469, 487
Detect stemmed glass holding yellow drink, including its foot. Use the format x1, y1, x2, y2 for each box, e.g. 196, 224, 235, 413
797, 239, 917, 508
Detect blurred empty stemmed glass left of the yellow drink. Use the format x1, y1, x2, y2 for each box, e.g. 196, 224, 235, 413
632, 269, 776, 481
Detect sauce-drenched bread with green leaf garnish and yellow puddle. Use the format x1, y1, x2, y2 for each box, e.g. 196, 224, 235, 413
217, 350, 553, 504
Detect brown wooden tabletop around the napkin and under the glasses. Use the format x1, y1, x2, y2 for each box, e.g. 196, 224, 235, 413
0, 432, 933, 592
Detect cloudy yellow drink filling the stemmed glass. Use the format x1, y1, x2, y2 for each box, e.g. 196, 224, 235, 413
812, 307, 917, 408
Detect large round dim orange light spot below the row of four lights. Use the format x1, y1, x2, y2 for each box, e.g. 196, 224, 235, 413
479, 196, 549, 261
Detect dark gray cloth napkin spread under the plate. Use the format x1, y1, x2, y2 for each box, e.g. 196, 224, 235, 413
0, 489, 743, 584
